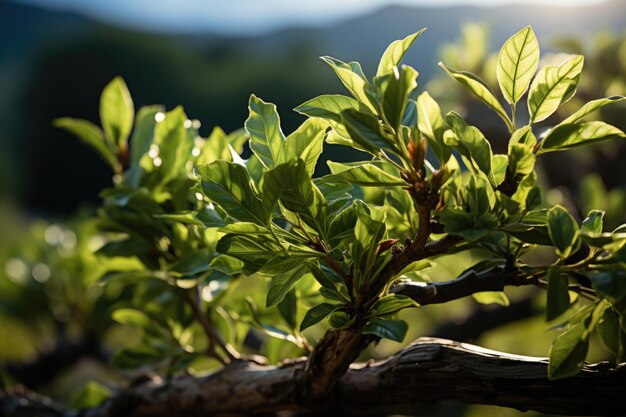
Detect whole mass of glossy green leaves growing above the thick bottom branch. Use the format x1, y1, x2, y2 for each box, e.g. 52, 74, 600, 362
1, 27, 626, 408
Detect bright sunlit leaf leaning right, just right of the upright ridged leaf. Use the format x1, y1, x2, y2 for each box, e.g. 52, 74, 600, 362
276, 119, 328, 176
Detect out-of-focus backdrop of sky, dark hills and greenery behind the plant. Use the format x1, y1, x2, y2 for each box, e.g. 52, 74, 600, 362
0, 0, 626, 415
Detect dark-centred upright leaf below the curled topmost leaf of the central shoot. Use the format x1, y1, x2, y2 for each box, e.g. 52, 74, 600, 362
381, 65, 418, 131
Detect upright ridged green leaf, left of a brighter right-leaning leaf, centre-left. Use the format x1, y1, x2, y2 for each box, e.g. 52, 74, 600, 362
245, 94, 285, 168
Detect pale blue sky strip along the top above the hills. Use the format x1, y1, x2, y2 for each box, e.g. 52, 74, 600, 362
20, 0, 602, 34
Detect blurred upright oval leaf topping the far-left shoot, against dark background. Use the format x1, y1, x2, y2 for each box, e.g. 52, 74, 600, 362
100, 77, 135, 148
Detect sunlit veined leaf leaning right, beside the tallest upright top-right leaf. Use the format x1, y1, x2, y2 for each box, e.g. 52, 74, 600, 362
528, 55, 584, 123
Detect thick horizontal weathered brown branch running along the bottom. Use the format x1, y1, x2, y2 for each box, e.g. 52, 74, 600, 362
7, 338, 626, 417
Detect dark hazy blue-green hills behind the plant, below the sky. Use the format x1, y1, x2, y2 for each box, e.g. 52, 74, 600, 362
0, 0, 626, 214
